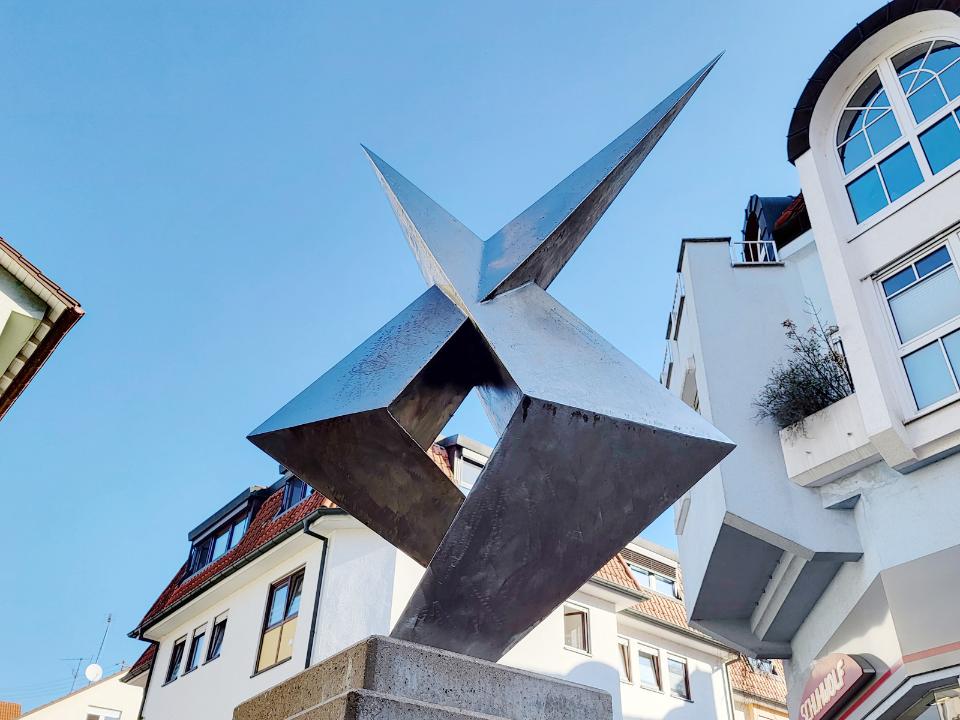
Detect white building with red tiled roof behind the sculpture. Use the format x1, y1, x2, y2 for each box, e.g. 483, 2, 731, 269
127, 436, 782, 720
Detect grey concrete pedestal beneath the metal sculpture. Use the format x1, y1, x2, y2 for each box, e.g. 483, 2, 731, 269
233, 635, 613, 720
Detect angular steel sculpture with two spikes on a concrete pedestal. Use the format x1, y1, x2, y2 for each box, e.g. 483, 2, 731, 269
250, 58, 733, 660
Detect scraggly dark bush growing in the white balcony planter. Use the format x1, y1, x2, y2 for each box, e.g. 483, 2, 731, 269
753, 300, 853, 434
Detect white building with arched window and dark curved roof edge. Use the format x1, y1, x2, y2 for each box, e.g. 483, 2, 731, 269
662, 7, 960, 720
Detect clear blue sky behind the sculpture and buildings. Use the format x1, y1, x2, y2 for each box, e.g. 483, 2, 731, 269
0, 0, 878, 706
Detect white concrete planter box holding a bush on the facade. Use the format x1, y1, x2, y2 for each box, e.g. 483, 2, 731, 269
780, 394, 880, 487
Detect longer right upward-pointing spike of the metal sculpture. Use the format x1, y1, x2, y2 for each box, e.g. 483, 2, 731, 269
479, 55, 721, 300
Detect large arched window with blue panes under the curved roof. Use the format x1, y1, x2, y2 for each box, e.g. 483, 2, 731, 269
837, 35, 960, 223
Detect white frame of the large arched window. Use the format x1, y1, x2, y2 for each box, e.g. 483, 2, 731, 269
829, 32, 960, 228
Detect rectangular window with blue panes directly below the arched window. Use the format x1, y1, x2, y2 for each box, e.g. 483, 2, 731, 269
880, 245, 960, 410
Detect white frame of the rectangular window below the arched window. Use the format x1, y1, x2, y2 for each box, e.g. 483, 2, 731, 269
876, 232, 960, 420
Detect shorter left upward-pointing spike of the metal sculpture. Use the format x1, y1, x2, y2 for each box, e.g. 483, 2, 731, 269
361, 145, 483, 307
